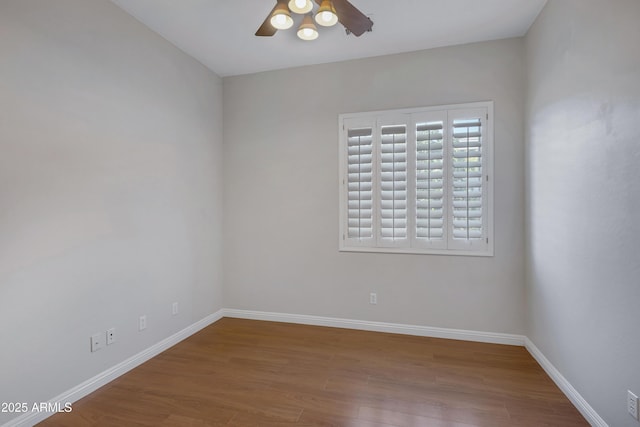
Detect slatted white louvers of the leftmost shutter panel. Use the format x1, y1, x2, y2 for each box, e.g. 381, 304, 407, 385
347, 128, 373, 239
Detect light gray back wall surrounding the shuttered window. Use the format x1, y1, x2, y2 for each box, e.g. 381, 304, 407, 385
224, 39, 525, 334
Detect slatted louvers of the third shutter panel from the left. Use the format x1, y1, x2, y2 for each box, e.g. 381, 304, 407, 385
415, 121, 445, 240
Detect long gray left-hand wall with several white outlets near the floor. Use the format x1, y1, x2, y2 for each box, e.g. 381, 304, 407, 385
0, 0, 222, 424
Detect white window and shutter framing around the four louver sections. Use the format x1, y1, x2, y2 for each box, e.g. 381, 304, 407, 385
338, 101, 494, 256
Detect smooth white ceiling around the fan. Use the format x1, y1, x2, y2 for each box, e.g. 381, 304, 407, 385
111, 0, 546, 77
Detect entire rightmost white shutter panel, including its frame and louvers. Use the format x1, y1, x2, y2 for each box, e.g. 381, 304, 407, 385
449, 109, 487, 252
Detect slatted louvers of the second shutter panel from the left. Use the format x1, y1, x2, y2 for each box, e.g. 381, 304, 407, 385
379, 124, 407, 245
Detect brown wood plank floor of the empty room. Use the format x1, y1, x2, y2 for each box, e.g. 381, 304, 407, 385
40, 318, 588, 427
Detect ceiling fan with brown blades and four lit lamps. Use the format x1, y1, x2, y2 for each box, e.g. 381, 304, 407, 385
256, 0, 373, 40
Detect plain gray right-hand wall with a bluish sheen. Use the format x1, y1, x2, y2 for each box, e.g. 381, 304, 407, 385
526, 0, 640, 427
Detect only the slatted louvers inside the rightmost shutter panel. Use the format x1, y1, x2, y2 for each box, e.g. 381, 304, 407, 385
451, 118, 484, 240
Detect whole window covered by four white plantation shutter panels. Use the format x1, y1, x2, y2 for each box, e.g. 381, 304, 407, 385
339, 102, 493, 256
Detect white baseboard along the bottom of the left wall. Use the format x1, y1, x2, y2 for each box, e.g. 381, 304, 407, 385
1, 310, 223, 427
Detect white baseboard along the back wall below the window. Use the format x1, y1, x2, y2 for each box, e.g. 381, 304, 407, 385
222, 308, 525, 346
